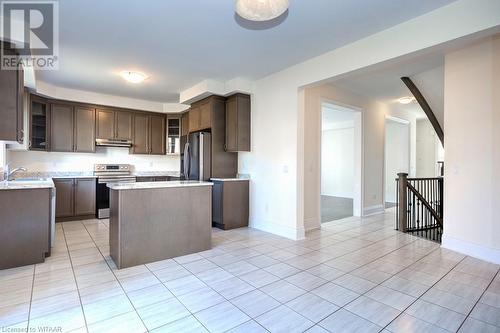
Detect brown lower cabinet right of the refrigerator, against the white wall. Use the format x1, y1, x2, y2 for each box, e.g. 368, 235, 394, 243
212, 179, 249, 230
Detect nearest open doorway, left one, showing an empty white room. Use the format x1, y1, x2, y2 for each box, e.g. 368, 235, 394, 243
320, 103, 362, 223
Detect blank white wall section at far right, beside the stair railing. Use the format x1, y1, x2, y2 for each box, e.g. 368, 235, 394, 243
443, 37, 500, 264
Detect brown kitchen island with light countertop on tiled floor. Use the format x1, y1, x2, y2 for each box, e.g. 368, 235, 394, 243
108, 181, 213, 269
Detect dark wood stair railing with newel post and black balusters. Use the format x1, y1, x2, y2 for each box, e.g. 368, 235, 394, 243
396, 173, 444, 243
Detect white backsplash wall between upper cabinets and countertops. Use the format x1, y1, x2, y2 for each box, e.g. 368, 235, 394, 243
7, 148, 180, 172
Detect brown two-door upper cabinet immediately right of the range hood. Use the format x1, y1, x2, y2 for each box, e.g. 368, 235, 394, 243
131, 113, 166, 155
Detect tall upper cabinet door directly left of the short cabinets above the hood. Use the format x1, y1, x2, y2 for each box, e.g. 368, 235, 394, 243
75, 106, 95, 153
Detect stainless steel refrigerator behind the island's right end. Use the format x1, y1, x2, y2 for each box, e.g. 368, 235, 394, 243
181, 132, 212, 180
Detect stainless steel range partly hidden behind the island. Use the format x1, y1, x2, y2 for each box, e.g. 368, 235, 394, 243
94, 164, 135, 219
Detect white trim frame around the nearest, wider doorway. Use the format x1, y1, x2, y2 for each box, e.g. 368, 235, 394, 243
317, 99, 364, 219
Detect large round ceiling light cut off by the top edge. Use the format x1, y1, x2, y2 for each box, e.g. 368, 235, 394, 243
236, 0, 289, 22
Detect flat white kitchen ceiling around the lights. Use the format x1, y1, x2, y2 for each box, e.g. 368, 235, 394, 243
37, 0, 454, 102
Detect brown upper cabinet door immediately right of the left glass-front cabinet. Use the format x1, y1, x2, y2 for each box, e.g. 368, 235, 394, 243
50, 104, 74, 152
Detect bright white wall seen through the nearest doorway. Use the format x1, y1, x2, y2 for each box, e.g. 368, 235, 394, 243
321, 122, 355, 199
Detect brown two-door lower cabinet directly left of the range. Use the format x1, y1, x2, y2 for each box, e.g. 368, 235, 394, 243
54, 178, 96, 221
